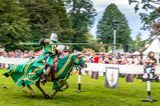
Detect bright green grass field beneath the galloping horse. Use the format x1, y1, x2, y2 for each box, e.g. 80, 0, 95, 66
0, 70, 160, 106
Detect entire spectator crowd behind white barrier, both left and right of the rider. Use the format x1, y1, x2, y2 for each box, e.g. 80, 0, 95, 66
0, 48, 144, 65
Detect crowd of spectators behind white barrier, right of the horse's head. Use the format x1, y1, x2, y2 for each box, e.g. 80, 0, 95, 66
84, 48, 144, 65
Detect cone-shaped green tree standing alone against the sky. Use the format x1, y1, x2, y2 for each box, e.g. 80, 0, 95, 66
97, 4, 132, 45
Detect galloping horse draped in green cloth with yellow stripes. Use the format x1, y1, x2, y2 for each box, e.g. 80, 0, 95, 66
3, 54, 86, 99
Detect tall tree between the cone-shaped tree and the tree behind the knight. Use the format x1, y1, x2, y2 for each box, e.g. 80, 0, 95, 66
66, 0, 96, 50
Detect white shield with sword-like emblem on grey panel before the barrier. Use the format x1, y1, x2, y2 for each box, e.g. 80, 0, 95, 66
105, 67, 119, 88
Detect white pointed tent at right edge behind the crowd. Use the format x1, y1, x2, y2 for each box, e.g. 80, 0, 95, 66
143, 38, 160, 54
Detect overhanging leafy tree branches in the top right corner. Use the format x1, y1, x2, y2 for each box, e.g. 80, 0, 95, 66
129, 0, 160, 36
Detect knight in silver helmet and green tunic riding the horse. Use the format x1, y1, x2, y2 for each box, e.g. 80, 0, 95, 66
37, 33, 65, 84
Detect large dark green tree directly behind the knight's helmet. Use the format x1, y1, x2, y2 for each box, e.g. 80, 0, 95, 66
20, 0, 72, 42
